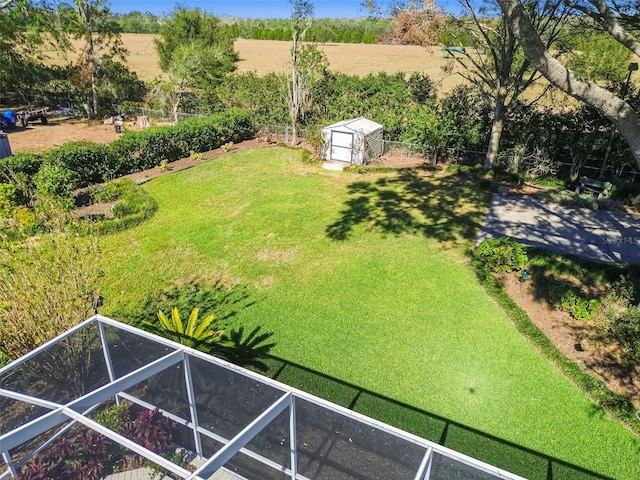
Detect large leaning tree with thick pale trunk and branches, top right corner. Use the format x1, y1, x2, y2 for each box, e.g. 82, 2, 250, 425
497, 0, 640, 166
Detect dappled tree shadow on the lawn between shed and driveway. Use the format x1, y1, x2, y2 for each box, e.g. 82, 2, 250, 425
326, 168, 491, 243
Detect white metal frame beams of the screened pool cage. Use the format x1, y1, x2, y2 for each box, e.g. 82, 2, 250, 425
0, 315, 525, 480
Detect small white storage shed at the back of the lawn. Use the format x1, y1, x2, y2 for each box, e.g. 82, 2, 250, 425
322, 117, 383, 165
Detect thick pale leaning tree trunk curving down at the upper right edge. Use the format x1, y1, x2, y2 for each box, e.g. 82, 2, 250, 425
498, 0, 640, 167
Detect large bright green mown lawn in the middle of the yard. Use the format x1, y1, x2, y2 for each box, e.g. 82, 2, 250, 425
97, 148, 640, 479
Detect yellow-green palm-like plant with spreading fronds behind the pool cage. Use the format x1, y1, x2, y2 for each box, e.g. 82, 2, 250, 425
142, 307, 234, 353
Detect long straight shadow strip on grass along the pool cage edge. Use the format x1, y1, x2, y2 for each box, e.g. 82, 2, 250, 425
258, 357, 624, 480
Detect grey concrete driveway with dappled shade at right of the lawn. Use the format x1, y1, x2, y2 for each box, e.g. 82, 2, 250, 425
476, 194, 640, 264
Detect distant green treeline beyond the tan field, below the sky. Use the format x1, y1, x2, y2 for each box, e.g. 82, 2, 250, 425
116, 12, 393, 43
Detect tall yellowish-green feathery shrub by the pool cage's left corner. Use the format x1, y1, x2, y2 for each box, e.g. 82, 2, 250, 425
0, 207, 101, 368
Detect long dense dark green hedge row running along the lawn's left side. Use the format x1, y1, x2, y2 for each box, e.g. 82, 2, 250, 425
0, 110, 256, 190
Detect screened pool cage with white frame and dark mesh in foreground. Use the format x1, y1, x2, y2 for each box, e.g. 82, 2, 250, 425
0, 315, 521, 480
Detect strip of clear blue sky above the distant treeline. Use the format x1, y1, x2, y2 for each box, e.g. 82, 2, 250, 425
109, 0, 368, 18
